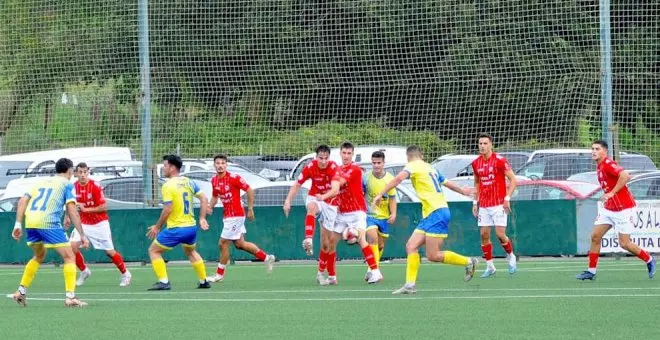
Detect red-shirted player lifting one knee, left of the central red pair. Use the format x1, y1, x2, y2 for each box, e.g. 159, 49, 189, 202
283, 145, 339, 284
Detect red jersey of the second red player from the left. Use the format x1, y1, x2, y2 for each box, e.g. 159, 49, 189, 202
211, 171, 250, 218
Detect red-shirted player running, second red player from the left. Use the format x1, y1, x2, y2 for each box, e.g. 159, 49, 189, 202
208, 155, 275, 282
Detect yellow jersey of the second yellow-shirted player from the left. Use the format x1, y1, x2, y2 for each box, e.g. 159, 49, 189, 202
161, 176, 201, 228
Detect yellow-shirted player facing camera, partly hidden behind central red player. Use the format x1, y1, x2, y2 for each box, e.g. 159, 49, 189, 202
363, 151, 397, 280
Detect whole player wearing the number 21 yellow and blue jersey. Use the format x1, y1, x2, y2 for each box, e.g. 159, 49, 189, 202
12, 158, 89, 307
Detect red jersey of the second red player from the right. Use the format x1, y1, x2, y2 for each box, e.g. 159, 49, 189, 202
472, 152, 511, 208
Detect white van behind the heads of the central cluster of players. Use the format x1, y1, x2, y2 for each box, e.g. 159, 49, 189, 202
287, 145, 408, 180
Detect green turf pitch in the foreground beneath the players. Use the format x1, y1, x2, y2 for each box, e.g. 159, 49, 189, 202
0, 258, 660, 339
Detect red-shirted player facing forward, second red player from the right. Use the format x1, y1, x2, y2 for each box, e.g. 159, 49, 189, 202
472, 134, 516, 278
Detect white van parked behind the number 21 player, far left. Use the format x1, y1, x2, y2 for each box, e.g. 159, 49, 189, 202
0, 147, 133, 197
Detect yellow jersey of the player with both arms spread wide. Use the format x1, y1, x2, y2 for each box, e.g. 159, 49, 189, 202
403, 160, 448, 217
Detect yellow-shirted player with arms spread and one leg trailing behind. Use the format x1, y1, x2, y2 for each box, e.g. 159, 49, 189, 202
373, 145, 478, 294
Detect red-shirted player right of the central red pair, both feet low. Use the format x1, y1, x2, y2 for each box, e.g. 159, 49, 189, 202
322, 142, 383, 285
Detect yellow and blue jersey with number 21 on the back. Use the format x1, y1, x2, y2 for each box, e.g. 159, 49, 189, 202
25, 176, 76, 229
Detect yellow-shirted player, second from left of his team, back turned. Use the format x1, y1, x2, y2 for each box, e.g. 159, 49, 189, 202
147, 155, 211, 290
